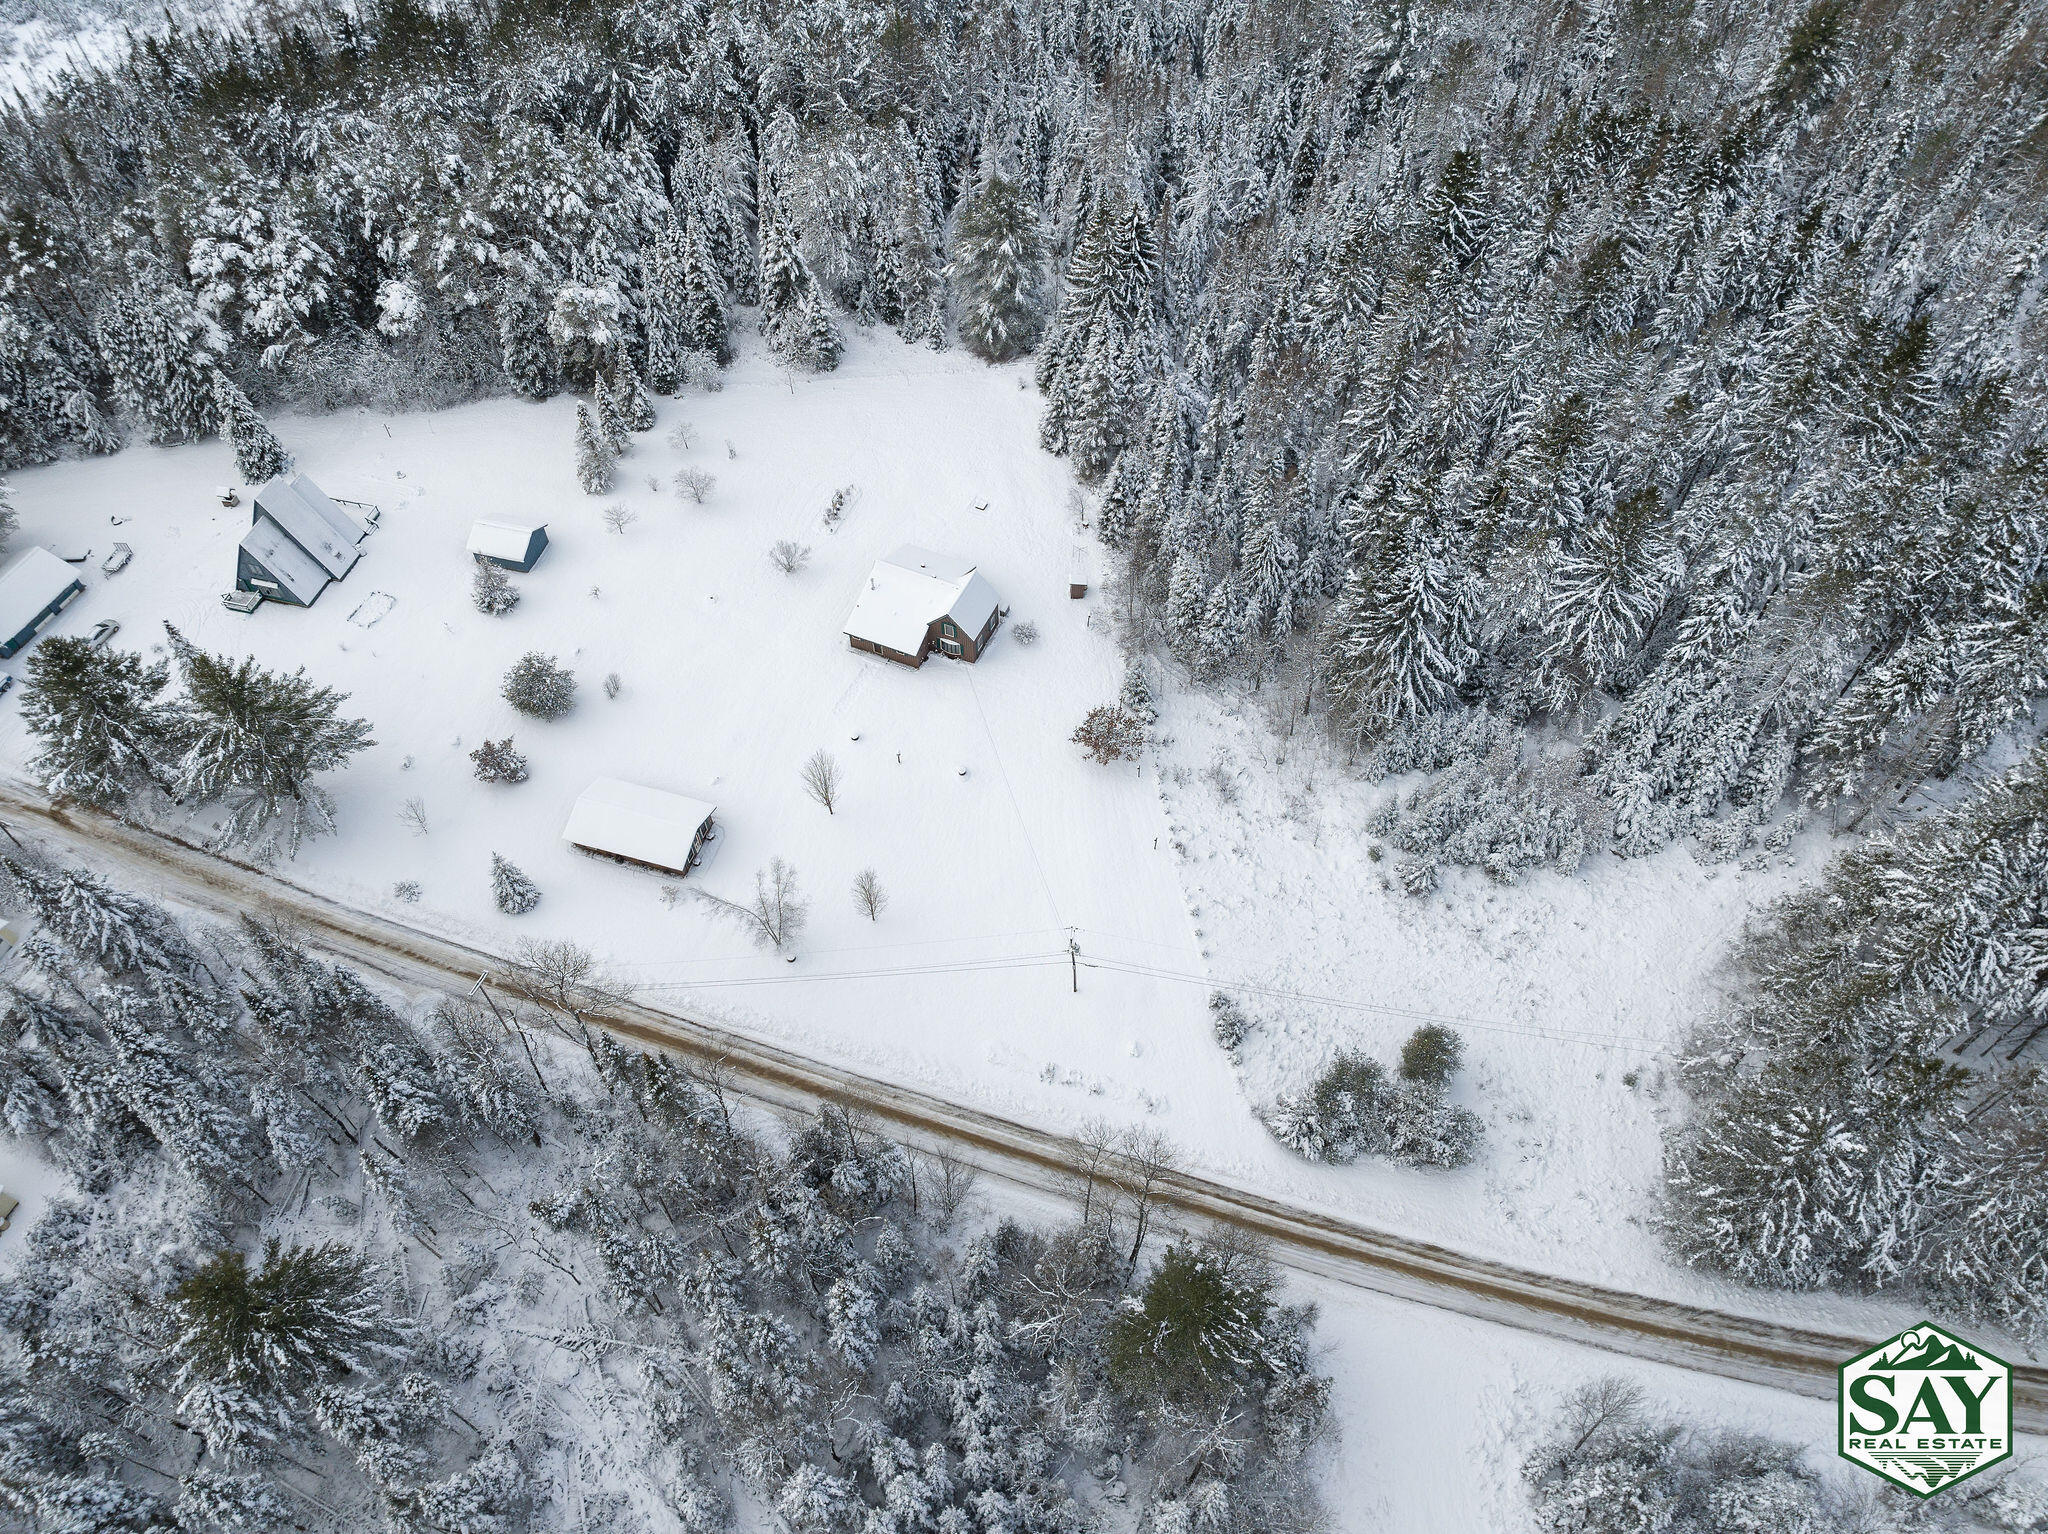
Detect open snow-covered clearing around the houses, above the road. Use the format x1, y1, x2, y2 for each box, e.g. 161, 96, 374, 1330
0, 325, 1933, 1331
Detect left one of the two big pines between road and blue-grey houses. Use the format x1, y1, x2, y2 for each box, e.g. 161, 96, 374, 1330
20, 635, 178, 809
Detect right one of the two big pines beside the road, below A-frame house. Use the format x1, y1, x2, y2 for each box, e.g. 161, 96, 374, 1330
164, 625, 375, 856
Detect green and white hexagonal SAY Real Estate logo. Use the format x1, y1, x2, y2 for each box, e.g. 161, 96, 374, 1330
1841, 1321, 2013, 1497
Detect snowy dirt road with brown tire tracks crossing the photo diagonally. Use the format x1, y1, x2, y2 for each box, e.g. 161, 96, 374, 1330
0, 784, 2048, 1432
